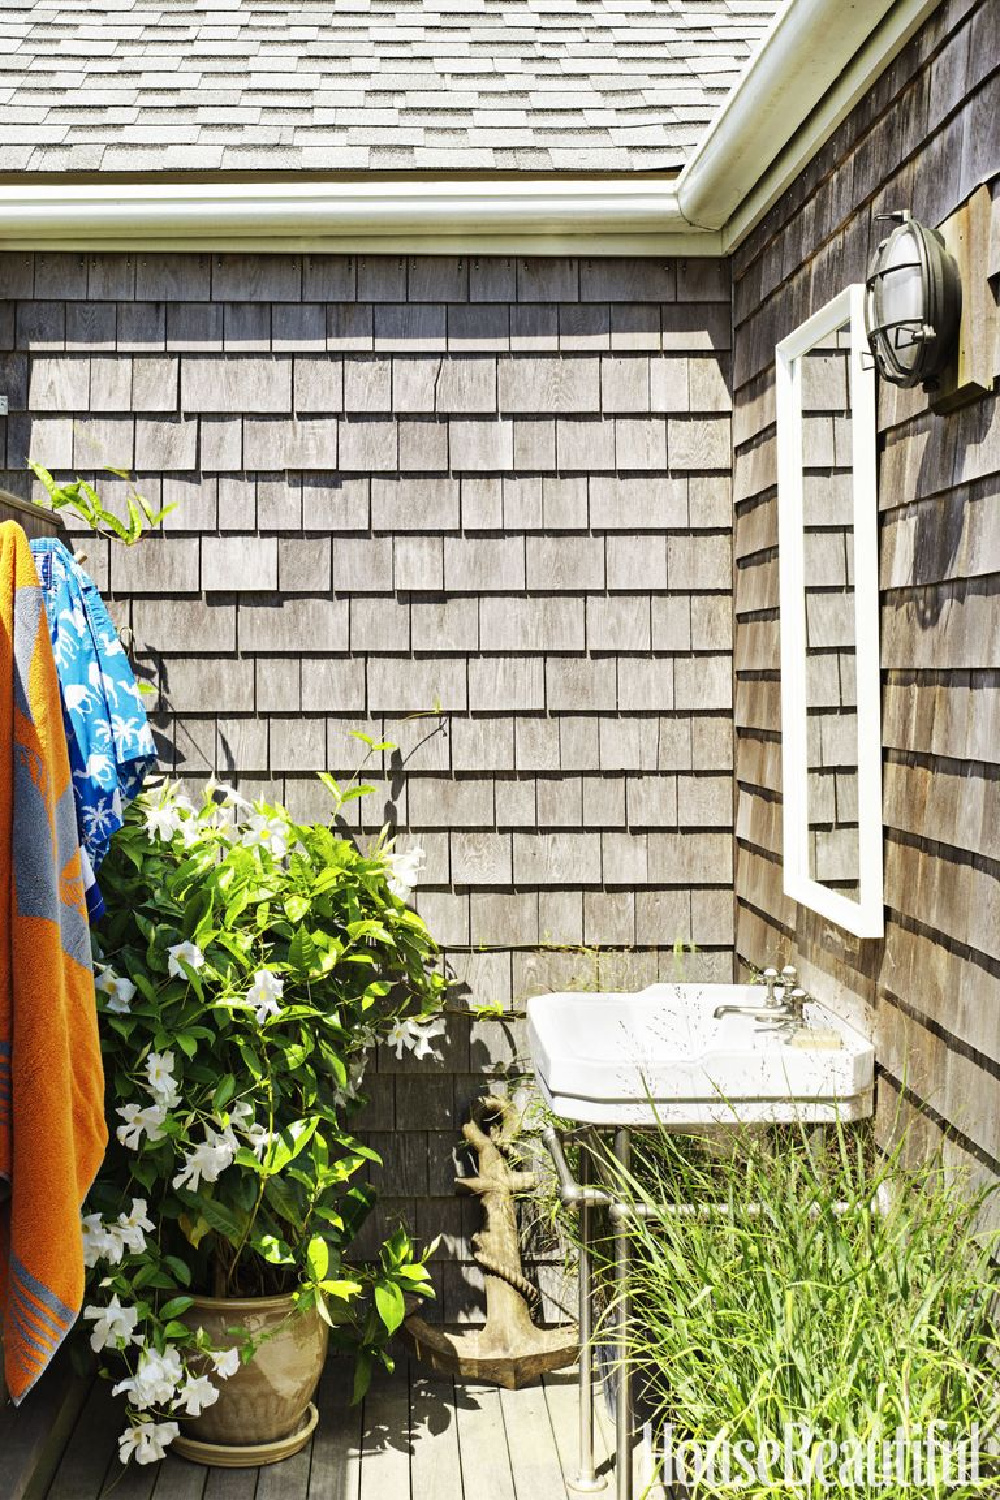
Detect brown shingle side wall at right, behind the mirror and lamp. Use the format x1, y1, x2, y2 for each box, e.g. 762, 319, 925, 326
733, 0, 1000, 1194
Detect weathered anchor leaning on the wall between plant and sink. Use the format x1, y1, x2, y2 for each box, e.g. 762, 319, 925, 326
405, 1095, 577, 1391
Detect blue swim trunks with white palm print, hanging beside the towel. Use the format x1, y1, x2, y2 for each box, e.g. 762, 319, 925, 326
31, 537, 156, 920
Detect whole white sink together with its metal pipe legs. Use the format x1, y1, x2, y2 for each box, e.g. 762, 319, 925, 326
528, 971, 876, 1500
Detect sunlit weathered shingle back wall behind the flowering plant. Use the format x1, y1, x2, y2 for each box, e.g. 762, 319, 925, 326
0, 255, 733, 1317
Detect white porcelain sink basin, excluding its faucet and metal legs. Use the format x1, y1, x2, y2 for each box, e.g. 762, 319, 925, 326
528, 984, 876, 1130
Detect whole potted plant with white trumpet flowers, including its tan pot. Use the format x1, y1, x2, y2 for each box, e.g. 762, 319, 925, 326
84, 777, 444, 1464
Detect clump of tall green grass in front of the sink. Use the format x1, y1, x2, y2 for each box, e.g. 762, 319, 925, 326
606, 1128, 1000, 1500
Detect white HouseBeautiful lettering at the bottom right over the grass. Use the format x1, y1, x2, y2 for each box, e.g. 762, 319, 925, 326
645, 1421, 1000, 1494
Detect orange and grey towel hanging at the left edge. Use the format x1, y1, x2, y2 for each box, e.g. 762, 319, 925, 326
0, 522, 108, 1401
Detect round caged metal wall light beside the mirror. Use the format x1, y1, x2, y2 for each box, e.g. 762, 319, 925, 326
865, 209, 961, 390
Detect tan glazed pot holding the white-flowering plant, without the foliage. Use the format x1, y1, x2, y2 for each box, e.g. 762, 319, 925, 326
175, 1296, 328, 1466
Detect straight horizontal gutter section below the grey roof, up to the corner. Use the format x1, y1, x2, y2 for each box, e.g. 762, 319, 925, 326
0, 177, 721, 255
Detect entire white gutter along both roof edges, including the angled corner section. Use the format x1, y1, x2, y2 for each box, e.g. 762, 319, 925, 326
0, 0, 940, 257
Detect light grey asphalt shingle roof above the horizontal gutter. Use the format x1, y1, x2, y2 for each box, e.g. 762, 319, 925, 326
0, 0, 778, 173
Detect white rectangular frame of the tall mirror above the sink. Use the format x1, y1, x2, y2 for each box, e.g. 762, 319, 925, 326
775, 284, 885, 938
